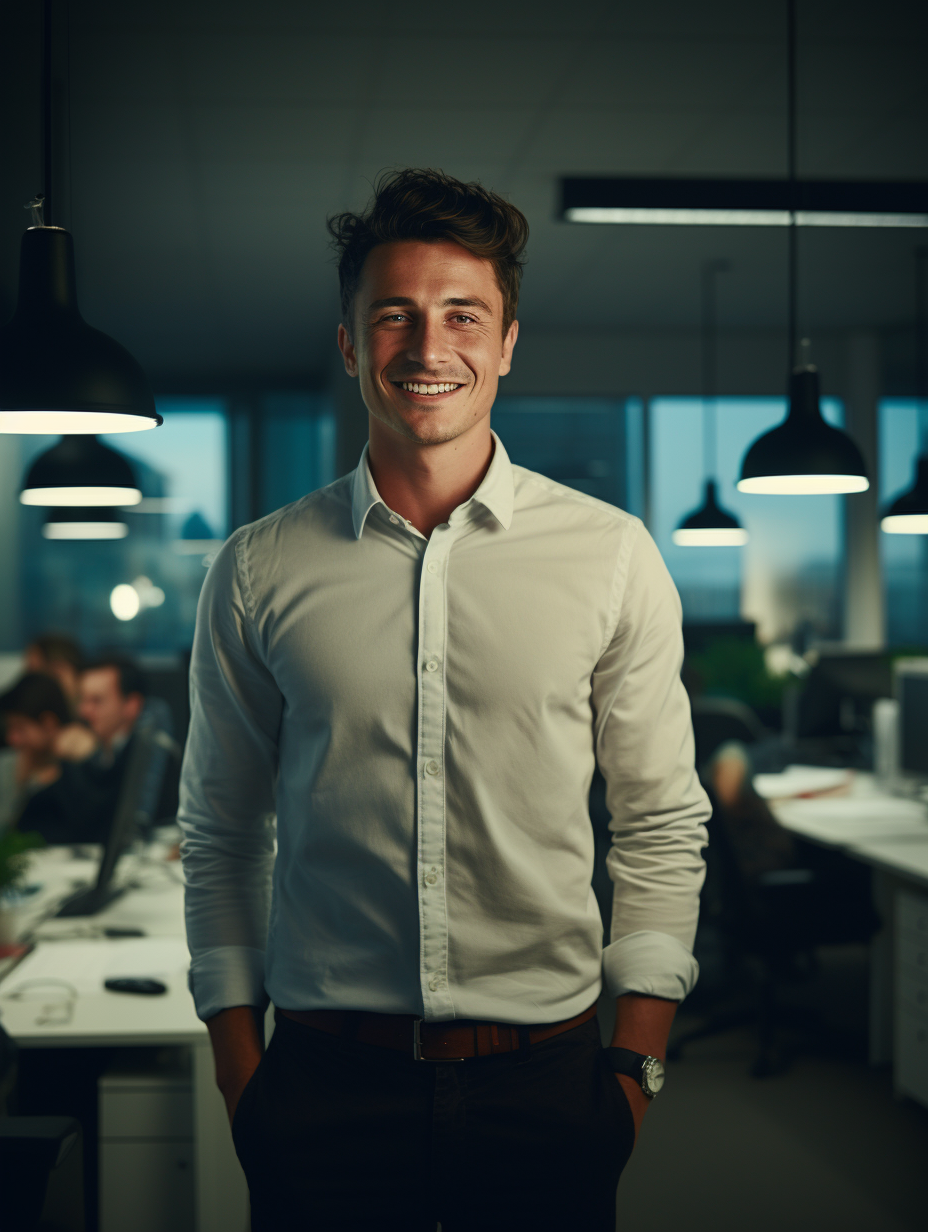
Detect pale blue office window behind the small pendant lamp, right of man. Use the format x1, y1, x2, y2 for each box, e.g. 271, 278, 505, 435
648, 397, 843, 642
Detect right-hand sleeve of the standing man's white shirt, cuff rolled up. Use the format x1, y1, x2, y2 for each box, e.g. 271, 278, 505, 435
593, 524, 711, 1000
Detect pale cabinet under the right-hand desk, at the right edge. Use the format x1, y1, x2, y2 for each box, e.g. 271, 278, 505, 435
893, 890, 928, 1108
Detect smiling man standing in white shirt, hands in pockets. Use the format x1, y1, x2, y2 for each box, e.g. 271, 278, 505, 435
179, 170, 707, 1232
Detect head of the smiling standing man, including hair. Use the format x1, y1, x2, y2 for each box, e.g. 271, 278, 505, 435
328, 169, 529, 445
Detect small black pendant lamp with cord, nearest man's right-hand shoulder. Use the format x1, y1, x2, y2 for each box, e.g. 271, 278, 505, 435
672, 261, 748, 547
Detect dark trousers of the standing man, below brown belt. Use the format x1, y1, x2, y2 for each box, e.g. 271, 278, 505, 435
233, 1014, 635, 1232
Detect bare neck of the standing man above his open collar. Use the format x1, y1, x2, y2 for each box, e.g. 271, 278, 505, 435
367, 416, 493, 538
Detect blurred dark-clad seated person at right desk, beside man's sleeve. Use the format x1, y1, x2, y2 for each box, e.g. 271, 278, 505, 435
701, 740, 881, 945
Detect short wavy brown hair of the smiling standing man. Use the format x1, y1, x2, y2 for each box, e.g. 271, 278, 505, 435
327, 168, 529, 334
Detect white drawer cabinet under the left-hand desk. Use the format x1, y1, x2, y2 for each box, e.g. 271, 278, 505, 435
99, 1048, 196, 1232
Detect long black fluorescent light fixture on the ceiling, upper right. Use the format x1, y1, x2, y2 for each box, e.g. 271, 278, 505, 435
561, 176, 928, 228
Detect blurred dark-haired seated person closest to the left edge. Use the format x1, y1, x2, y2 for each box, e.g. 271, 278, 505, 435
0, 671, 100, 844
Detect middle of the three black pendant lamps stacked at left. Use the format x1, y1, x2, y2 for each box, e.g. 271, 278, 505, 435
20, 436, 142, 506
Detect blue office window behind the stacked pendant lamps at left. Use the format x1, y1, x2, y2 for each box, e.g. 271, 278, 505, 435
18, 398, 229, 653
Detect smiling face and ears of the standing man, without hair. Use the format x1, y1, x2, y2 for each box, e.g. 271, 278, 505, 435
339, 240, 519, 445
